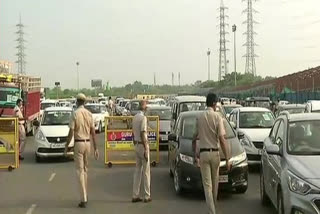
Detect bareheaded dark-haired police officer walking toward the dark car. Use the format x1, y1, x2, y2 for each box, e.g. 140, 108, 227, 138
192, 93, 231, 214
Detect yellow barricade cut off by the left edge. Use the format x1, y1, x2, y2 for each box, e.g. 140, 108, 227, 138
0, 118, 19, 171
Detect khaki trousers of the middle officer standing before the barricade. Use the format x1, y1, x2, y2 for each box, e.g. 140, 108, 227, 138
132, 144, 150, 199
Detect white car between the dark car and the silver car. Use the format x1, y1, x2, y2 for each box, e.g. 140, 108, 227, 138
229, 107, 274, 164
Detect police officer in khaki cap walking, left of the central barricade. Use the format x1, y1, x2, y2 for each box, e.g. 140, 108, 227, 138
65, 94, 99, 208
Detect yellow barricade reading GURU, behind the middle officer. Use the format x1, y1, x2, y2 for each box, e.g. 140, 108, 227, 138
105, 116, 160, 167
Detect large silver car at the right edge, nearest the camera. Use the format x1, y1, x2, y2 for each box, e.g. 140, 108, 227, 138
260, 113, 320, 214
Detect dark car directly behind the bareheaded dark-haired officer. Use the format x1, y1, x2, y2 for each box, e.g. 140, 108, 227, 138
168, 111, 248, 194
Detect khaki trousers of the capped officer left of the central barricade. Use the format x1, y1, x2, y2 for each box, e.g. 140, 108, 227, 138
74, 142, 91, 202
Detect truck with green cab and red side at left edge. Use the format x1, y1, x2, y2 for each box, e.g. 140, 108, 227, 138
0, 73, 41, 135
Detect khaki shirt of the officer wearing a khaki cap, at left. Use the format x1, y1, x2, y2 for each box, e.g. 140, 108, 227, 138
69, 106, 94, 140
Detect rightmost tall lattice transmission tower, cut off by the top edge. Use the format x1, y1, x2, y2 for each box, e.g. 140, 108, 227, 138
243, 0, 257, 75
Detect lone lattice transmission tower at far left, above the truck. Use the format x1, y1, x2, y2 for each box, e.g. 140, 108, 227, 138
16, 15, 26, 74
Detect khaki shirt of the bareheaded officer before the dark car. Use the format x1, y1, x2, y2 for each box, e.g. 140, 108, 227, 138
197, 107, 226, 149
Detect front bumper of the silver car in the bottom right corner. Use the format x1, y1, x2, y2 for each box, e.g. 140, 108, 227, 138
284, 189, 320, 214
